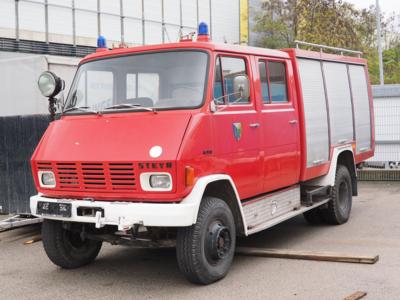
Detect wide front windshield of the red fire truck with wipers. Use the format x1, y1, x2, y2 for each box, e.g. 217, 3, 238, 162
65, 50, 208, 113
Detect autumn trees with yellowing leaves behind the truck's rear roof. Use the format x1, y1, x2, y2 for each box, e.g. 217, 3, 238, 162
253, 0, 400, 83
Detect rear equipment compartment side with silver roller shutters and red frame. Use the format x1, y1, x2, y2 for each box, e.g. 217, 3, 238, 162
284, 49, 375, 181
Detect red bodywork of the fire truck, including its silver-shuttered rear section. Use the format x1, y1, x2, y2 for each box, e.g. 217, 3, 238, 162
32, 38, 374, 233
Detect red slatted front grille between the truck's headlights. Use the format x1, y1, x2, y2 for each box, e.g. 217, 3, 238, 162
37, 162, 136, 192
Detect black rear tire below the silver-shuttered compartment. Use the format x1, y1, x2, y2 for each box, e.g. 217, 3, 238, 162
321, 165, 353, 225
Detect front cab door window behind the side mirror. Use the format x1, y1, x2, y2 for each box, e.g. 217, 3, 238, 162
214, 56, 250, 104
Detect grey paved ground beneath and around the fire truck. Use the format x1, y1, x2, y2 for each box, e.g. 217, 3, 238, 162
0, 182, 400, 300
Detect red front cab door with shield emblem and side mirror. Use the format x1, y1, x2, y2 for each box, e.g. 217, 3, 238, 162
212, 54, 262, 199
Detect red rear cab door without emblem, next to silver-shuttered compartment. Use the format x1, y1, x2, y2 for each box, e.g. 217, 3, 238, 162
257, 58, 300, 192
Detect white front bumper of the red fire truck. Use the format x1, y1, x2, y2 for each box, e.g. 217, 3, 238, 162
30, 194, 198, 230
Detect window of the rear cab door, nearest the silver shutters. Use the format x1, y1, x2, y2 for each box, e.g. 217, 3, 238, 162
258, 60, 289, 103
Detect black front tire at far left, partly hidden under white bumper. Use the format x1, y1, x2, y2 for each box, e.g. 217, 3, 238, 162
42, 220, 102, 269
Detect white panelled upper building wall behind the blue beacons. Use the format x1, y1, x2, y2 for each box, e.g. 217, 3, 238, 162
0, 0, 239, 46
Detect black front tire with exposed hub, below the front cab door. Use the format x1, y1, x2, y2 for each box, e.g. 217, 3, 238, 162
176, 197, 236, 284
